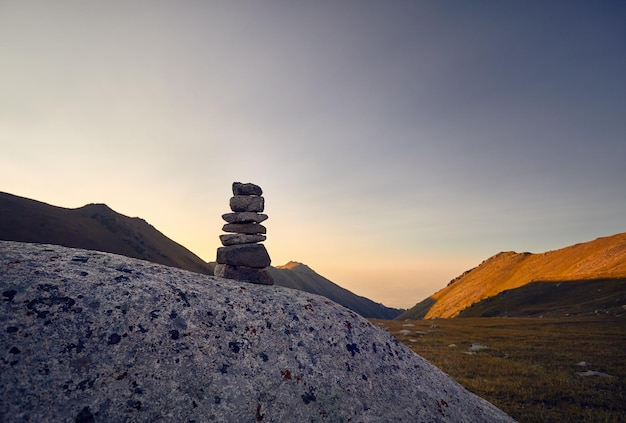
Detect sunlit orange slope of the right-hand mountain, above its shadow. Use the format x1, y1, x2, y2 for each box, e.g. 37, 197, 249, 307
397, 233, 626, 319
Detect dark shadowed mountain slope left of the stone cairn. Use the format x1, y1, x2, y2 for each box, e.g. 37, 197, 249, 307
0, 192, 213, 274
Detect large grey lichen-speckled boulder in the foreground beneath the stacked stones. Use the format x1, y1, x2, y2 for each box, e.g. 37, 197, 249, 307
0, 241, 512, 423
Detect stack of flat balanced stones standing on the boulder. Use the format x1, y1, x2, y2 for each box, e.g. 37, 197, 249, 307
214, 182, 274, 285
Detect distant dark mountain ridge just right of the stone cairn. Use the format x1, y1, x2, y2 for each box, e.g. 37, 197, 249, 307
268, 261, 404, 319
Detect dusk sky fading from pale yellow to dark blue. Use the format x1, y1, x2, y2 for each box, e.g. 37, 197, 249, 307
0, 0, 626, 308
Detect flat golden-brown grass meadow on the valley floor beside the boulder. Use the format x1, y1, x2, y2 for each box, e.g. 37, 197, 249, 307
372, 317, 626, 423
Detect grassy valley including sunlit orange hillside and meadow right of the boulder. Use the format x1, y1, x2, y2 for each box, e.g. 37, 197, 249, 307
388, 233, 626, 423
